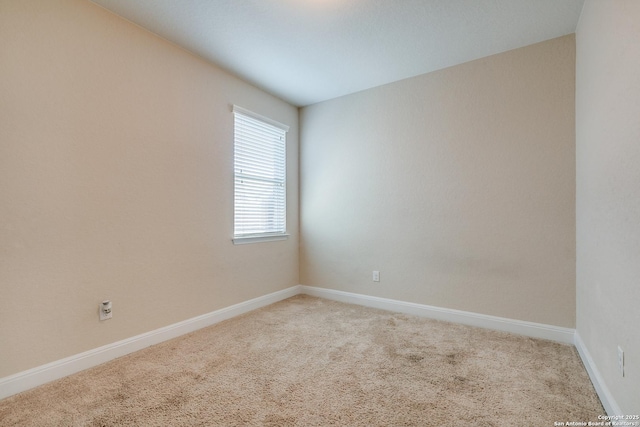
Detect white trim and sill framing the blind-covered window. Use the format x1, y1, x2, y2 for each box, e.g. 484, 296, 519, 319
231, 105, 290, 245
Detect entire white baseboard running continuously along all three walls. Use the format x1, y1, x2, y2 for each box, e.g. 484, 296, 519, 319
0, 285, 608, 415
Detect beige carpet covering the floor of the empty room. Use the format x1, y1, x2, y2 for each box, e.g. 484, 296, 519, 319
0, 296, 604, 426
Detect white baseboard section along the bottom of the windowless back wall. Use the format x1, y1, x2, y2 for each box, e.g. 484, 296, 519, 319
301, 285, 575, 344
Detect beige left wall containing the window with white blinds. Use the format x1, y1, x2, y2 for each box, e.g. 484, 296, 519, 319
0, 0, 298, 377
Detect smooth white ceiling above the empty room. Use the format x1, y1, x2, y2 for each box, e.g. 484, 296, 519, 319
92, 0, 584, 106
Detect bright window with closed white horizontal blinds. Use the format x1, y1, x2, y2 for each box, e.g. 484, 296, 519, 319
233, 105, 289, 244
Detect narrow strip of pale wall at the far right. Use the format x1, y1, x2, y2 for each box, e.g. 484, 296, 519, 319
576, 0, 640, 414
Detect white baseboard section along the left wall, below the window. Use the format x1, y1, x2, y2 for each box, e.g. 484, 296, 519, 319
0, 285, 300, 399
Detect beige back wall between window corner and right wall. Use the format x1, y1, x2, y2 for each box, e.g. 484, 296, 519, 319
300, 35, 575, 327
